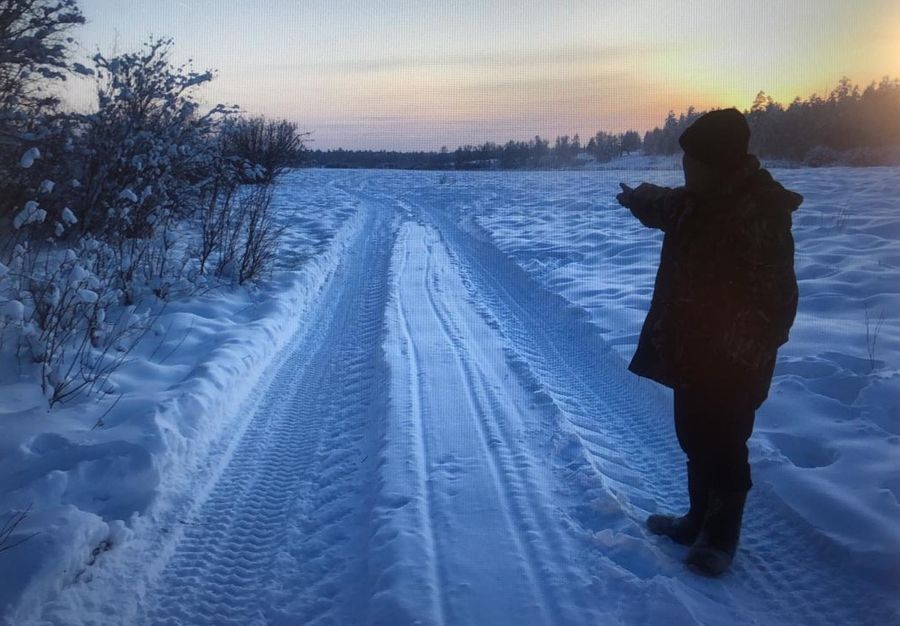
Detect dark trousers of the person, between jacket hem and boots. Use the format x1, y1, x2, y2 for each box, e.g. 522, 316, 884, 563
675, 389, 756, 491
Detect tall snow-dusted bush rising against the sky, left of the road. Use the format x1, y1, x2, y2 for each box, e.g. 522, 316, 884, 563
49, 39, 241, 305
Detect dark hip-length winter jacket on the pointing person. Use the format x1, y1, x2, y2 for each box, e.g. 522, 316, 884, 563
629, 157, 803, 408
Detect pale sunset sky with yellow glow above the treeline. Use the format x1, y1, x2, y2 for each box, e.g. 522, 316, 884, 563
71, 0, 900, 150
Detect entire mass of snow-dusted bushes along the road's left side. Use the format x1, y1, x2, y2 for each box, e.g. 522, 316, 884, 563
0, 19, 302, 406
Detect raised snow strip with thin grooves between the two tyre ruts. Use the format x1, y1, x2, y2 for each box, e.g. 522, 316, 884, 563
387, 222, 590, 624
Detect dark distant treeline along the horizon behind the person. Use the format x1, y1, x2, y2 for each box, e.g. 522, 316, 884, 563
304, 78, 900, 169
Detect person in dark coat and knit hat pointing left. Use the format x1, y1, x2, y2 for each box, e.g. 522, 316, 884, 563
617, 109, 803, 576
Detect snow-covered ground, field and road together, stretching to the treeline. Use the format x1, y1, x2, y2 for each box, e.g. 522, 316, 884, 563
0, 163, 900, 625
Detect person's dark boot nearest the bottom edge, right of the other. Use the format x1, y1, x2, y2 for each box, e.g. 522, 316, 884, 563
684, 489, 747, 578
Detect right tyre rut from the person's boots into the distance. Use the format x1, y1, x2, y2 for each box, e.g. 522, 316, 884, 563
418, 194, 685, 521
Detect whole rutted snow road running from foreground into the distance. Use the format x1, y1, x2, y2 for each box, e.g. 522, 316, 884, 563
26, 174, 896, 625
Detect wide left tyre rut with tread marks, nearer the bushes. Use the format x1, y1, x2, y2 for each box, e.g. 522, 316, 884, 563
142, 205, 390, 624
